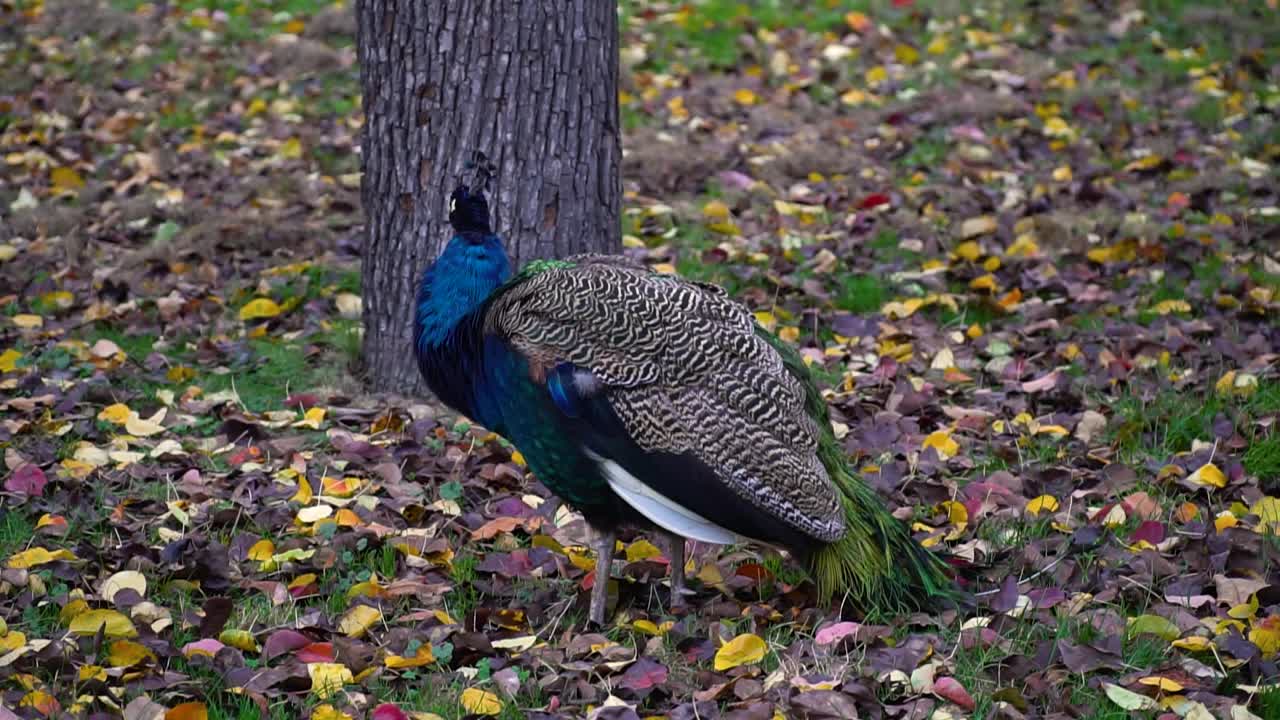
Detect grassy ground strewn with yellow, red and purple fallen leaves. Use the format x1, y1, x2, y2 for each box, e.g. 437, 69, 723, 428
0, 0, 1280, 720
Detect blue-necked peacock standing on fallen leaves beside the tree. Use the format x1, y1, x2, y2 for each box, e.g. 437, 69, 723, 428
413, 170, 956, 625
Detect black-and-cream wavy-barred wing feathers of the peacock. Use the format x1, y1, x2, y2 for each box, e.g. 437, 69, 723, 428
485, 256, 845, 541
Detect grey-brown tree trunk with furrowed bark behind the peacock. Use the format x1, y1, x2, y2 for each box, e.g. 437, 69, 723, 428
356, 0, 622, 395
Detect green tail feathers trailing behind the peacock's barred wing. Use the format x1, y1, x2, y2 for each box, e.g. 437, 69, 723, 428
756, 327, 961, 614
